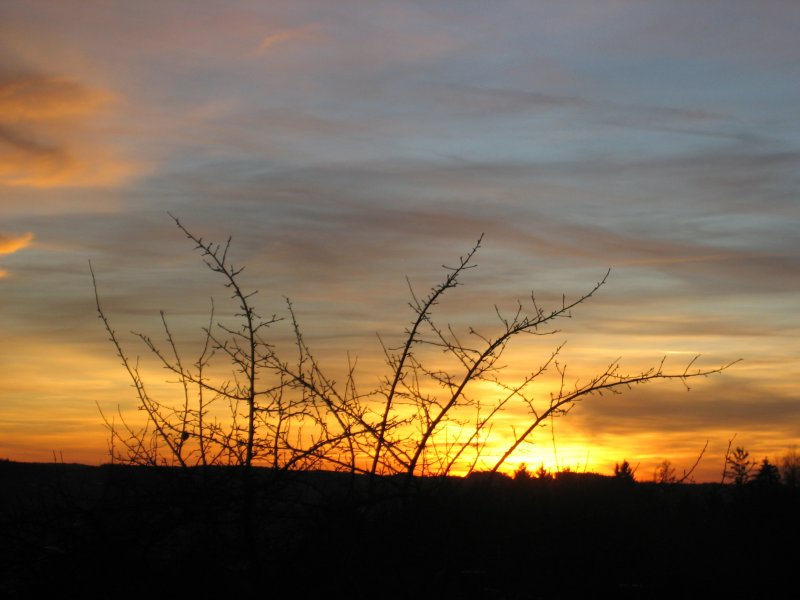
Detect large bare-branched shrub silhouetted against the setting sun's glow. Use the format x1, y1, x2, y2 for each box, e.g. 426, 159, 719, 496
90, 217, 733, 478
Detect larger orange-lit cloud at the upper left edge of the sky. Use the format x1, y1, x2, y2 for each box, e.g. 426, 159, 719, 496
0, 74, 136, 188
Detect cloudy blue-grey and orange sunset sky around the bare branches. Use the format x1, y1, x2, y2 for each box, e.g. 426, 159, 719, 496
0, 0, 800, 481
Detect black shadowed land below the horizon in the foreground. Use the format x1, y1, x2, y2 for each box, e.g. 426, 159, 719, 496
0, 461, 800, 599
